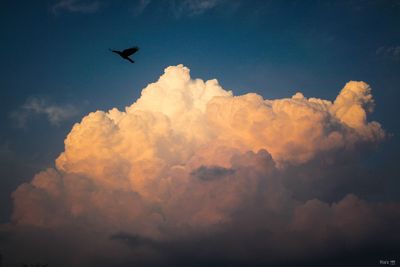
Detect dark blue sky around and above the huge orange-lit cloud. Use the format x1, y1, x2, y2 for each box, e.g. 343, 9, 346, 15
0, 0, 400, 221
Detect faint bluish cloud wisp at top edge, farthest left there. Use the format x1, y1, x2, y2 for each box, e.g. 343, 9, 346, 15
51, 0, 100, 14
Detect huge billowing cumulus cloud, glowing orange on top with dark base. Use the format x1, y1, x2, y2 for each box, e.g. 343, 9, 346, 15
6, 65, 400, 266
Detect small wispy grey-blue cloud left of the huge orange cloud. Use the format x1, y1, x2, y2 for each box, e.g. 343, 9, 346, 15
10, 97, 79, 127
